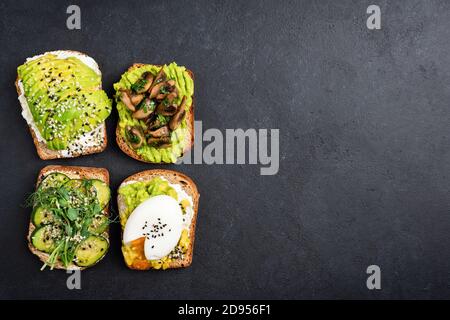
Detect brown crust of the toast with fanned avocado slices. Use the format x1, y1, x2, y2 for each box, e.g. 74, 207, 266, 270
15, 50, 108, 160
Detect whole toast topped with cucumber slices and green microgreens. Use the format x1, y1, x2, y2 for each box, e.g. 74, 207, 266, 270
27, 165, 111, 270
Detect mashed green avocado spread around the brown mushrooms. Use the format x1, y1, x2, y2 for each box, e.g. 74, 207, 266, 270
114, 62, 194, 163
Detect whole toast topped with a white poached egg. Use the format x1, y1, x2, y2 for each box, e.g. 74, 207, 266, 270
117, 169, 200, 270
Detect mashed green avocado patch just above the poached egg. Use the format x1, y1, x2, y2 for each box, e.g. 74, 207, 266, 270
118, 177, 178, 227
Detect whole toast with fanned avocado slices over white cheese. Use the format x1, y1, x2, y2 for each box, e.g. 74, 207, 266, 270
15, 50, 111, 160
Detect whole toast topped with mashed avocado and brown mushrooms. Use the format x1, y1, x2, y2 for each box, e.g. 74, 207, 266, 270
114, 62, 194, 163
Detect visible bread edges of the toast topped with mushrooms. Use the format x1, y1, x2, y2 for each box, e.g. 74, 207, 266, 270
116, 63, 194, 164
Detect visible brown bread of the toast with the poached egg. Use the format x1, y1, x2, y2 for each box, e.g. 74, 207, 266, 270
117, 169, 200, 270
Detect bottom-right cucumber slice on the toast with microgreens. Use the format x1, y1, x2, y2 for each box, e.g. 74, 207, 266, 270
75, 236, 109, 267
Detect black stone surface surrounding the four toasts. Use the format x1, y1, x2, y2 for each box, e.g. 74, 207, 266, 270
0, 0, 450, 299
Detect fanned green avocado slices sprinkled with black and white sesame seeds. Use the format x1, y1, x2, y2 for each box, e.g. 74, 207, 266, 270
17, 53, 111, 150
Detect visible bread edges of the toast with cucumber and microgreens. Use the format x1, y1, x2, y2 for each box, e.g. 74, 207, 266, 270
27, 165, 109, 270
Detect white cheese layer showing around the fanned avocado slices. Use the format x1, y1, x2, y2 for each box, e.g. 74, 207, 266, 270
18, 50, 105, 157
